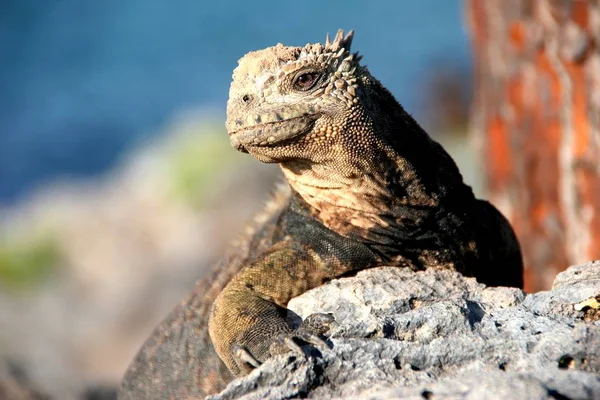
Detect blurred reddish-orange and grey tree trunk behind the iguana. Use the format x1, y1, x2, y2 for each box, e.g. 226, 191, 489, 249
466, 0, 600, 291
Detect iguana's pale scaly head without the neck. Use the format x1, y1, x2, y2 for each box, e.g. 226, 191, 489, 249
226, 30, 368, 162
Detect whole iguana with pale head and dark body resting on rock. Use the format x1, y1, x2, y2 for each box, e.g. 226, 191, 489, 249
120, 30, 523, 399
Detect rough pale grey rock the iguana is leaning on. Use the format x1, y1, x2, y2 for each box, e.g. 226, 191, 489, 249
212, 261, 600, 400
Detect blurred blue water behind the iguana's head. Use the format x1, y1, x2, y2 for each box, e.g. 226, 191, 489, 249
0, 0, 468, 203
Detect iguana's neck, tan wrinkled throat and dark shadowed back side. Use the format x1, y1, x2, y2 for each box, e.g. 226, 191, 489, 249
281, 82, 473, 250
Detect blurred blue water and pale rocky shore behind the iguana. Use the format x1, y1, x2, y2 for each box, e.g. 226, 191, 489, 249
0, 0, 481, 399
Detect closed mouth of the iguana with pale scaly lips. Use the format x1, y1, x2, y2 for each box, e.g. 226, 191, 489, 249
229, 115, 314, 151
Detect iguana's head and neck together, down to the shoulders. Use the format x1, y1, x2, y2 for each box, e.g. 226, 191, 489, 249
227, 30, 464, 241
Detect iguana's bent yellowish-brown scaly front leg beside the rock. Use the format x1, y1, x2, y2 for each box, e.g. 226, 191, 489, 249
208, 242, 344, 376
